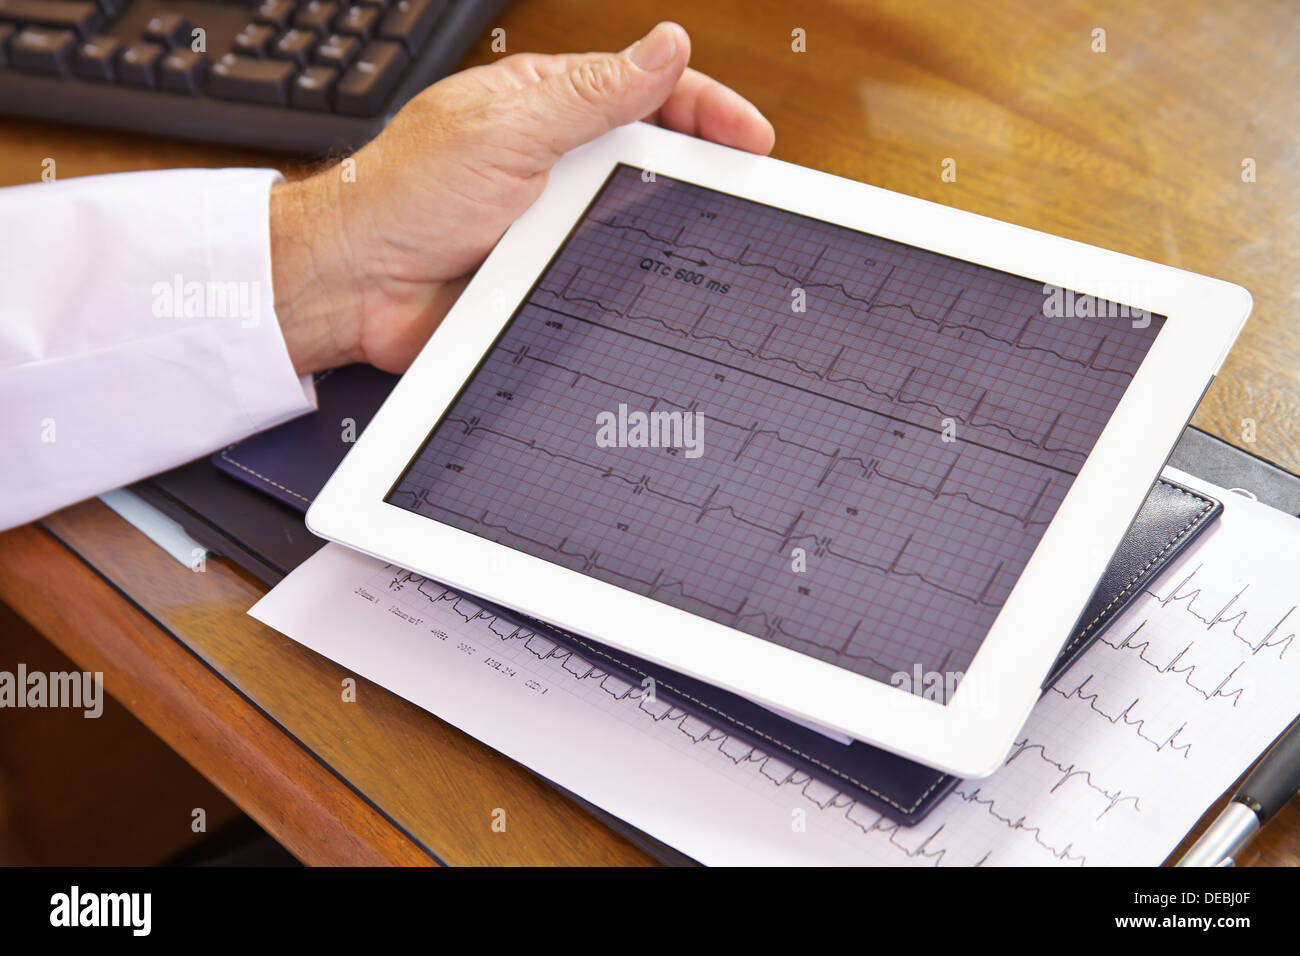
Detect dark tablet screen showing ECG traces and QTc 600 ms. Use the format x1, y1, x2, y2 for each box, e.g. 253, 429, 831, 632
385, 165, 1164, 696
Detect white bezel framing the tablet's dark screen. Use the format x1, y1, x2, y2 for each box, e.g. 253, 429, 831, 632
307, 124, 1251, 777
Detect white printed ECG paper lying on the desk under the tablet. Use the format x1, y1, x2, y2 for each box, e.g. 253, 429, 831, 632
251, 472, 1300, 866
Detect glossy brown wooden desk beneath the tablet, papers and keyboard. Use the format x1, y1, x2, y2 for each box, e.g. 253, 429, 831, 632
0, 0, 1300, 865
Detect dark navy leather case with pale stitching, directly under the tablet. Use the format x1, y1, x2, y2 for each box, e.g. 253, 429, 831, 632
152, 365, 1248, 825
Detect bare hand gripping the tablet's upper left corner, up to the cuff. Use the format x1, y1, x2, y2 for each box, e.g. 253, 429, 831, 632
270, 22, 774, 372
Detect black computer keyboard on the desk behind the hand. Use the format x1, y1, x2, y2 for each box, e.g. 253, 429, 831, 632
0, 0, 508, 153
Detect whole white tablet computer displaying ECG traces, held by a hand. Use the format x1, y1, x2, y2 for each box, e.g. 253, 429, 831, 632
307, 124, 1251, 777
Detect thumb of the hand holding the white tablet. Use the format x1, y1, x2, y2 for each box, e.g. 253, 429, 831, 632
516, 21, 690, 165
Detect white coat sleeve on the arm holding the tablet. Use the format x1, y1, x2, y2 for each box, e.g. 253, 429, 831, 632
0, 169, 316, 529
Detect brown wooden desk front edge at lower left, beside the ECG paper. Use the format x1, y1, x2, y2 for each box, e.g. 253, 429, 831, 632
8, 501, 649, 865
